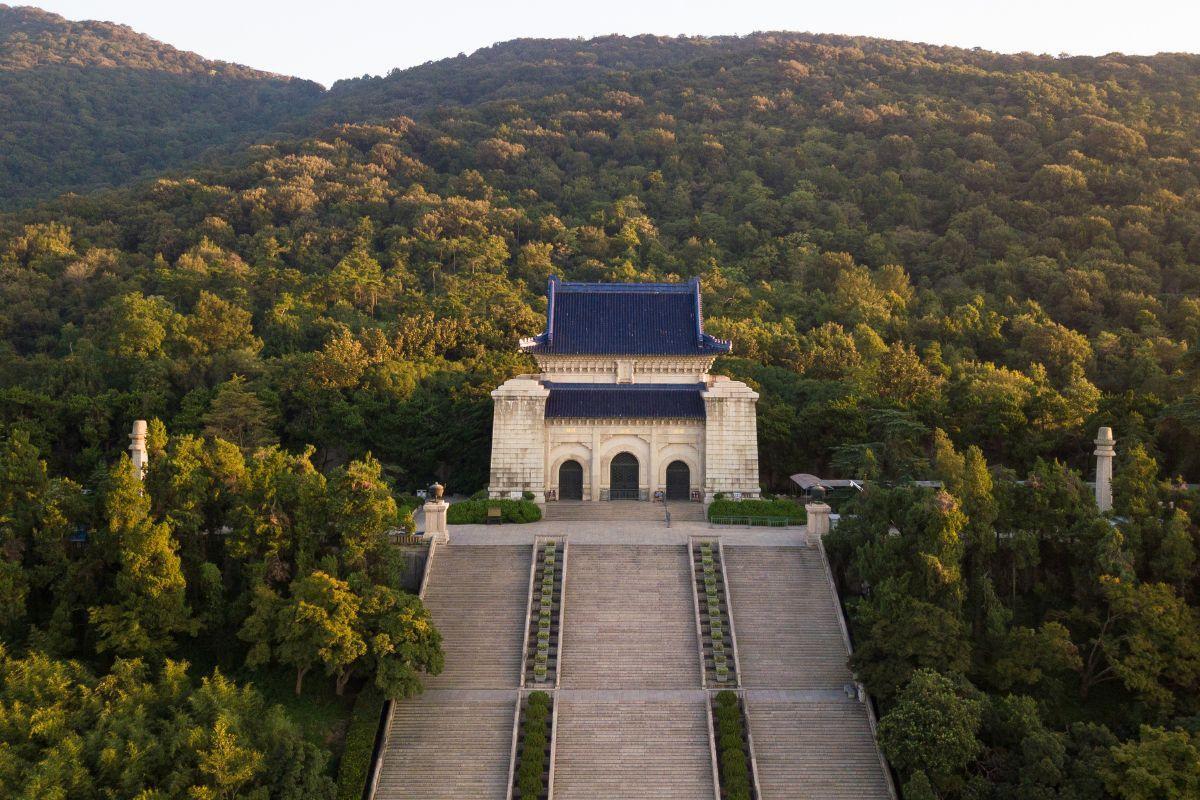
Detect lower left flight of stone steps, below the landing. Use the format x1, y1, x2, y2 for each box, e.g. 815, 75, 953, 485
374, 692, 516, 800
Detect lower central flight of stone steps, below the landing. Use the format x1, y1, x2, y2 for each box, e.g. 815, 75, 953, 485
554, 700, 714, 800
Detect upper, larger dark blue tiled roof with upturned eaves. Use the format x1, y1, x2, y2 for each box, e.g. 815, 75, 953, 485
521, 278, 730, 355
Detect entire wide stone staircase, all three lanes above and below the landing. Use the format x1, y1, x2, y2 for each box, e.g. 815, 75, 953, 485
373, 537, 893, 800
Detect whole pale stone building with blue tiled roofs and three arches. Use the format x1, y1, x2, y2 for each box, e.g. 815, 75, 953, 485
488, 278, 760, 503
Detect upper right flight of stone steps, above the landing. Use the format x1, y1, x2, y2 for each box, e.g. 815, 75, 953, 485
725, 541, 852, 688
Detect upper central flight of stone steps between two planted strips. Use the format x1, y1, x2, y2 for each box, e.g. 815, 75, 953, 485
560, 545, 700, 688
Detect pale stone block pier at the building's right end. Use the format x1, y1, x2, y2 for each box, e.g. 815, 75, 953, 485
703, 375, 761, 503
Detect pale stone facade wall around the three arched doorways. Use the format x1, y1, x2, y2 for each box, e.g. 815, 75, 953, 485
545, 420, 704, 500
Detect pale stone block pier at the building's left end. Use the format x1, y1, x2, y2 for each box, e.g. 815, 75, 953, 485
487, 375, 550, 503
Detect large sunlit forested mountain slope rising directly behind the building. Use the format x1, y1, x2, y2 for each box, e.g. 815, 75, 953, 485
7, 34, 1200, 488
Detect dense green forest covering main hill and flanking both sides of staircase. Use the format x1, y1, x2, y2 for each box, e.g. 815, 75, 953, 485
0, 14, 1200, 800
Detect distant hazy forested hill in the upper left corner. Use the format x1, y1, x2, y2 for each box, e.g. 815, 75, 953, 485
0, 5, 322, 207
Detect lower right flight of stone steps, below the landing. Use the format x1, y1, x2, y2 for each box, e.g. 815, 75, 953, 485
749, 693, 890, 800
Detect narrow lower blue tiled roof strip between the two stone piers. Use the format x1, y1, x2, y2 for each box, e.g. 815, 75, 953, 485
542, 380, 704, 420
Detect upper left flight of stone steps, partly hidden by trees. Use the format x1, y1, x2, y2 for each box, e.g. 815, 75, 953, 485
425, 545, 532, 688
